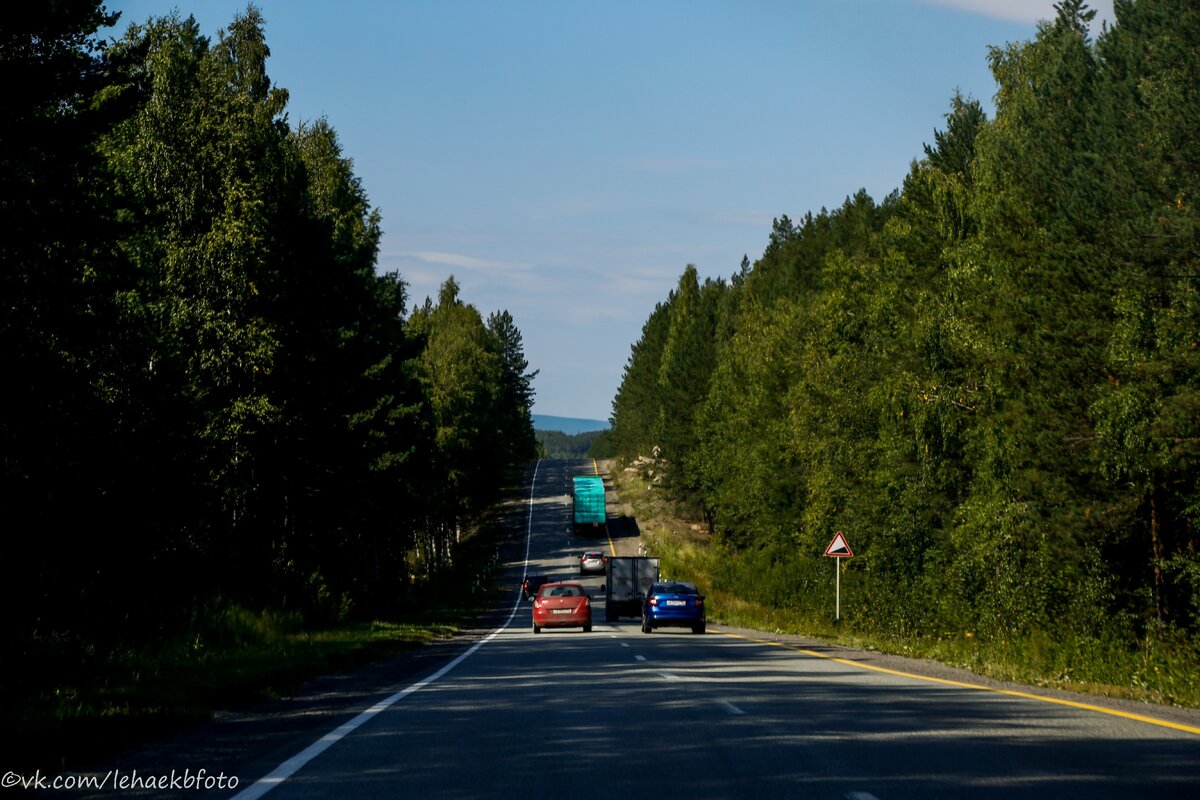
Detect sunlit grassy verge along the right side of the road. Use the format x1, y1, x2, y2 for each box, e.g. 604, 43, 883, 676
613, 467, 1200, 708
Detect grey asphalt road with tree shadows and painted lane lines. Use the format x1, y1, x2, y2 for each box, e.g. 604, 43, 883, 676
39, 461, 1200, 800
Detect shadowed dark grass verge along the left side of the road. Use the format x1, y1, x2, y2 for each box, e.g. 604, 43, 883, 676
8, 479, 525, 771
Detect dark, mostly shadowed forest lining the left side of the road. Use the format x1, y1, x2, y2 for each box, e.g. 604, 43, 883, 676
0, 0, 535, 676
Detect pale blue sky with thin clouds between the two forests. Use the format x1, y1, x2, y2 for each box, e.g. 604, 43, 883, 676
106, 0, 1112, 420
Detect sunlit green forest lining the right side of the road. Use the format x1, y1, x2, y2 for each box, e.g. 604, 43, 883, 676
612, 0, 1200, 696
